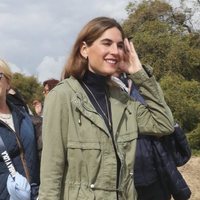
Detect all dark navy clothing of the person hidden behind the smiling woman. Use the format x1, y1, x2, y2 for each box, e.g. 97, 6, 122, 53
130, 86, 191, 200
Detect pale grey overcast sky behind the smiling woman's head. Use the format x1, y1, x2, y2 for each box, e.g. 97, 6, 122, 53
0, 0, 195, 82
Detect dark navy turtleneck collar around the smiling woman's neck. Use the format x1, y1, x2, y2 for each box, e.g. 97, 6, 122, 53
82, 70, 108, 92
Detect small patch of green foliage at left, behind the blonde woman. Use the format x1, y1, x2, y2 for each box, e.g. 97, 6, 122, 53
11, 73, 43, 108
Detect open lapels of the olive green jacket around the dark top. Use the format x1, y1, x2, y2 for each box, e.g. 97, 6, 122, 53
64, 77, 128, 136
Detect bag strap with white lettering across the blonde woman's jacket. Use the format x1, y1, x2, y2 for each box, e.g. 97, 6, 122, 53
0, 135, 16, 180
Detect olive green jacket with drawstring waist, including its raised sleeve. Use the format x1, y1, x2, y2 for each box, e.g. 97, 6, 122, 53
39, 70, 174, 200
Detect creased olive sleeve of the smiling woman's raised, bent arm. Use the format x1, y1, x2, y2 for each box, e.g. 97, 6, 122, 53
129, 67, 174, 135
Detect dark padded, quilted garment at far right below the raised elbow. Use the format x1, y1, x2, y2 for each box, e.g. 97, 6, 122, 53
152, 127, 191, 200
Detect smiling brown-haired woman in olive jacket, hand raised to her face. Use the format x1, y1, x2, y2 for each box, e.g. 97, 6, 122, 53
39, 17, 174, 200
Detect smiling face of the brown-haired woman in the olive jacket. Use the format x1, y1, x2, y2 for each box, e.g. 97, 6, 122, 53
81, 27, 124, 76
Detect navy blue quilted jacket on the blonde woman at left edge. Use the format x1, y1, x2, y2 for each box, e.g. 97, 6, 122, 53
0, 103, 39, 200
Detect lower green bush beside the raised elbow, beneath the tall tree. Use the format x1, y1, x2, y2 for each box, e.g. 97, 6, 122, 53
160, 73, 200, 132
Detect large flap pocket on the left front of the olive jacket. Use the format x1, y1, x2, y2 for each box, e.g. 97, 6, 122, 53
66, 141, 102, 194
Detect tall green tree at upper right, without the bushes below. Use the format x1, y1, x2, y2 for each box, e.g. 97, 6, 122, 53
123, 0, 200, 80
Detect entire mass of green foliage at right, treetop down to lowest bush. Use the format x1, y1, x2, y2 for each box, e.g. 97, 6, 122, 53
122, 0, 200, 150
